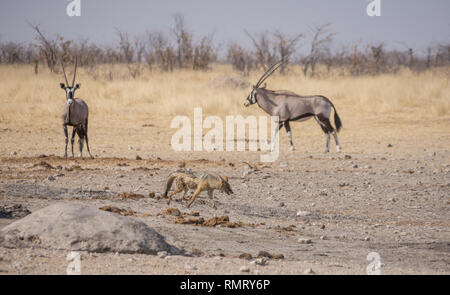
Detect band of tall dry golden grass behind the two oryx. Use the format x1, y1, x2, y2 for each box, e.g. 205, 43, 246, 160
0, 65, 450, 127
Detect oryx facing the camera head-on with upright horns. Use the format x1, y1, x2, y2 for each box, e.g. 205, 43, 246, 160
60, 59, 92, 158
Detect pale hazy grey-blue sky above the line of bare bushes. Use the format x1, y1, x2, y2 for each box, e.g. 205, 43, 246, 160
0, 0, 450, 51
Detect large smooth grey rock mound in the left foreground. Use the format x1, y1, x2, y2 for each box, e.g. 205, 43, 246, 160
0, 203, 180, 254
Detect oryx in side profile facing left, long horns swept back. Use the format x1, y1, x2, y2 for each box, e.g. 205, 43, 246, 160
244, 63, 342, 153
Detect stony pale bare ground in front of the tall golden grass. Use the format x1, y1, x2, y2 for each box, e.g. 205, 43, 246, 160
0, 118, 450, 274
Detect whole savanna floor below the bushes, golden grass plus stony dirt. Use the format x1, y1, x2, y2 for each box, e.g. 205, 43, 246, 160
0, 64, 450, 274
